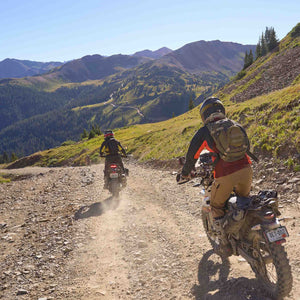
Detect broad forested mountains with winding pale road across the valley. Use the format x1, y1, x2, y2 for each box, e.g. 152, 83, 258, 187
0, 41, 260, 155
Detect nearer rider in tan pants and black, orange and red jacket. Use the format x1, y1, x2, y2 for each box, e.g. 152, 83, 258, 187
177, 98, 254, 254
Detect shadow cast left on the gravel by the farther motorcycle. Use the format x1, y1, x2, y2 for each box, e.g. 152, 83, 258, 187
74, 197, 120, 220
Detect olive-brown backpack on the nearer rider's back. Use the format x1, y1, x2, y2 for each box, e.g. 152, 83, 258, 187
206, 118, 250, 162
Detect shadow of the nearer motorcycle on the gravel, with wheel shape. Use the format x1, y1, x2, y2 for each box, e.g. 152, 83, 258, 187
192, 250, 271, 300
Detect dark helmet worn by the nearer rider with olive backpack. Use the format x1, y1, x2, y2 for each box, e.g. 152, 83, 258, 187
200, 98, 225, 124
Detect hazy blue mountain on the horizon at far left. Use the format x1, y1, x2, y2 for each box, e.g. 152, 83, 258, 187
0, 58, 63, 78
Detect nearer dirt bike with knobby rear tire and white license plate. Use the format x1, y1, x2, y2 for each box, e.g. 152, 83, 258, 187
178, 153, 292, 299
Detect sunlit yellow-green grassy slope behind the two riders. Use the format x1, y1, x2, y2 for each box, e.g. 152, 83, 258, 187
8, 83, 300, 167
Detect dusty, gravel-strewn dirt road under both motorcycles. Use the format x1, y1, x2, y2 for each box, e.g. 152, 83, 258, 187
0, 163, 300, 300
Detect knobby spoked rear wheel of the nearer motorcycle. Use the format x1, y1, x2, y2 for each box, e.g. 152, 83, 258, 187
251, 242, 293, 299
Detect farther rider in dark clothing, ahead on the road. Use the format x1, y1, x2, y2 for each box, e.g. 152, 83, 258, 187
99, 130, 127, 189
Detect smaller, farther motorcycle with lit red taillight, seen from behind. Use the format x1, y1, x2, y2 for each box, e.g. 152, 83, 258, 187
105, 156, 129, 198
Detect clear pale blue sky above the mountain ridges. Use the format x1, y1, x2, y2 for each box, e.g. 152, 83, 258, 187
0, 0, 300, 61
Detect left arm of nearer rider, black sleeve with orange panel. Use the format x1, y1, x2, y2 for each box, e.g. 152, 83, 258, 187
181, 126, 211, 176
